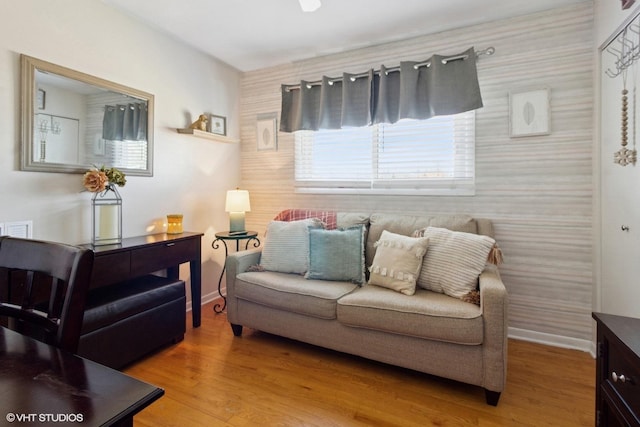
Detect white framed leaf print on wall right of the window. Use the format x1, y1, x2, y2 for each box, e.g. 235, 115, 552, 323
509, 88, 551, 138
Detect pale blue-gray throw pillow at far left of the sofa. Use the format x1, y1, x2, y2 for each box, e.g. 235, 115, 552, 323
260, 218, 322, 274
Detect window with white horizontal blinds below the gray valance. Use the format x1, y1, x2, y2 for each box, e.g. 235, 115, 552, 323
295, 111, 475, 195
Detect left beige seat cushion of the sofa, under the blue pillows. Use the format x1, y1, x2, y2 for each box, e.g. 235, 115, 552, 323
235, 271, 358, 319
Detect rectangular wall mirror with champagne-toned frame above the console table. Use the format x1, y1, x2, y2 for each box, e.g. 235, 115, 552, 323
21, 55, 153, 176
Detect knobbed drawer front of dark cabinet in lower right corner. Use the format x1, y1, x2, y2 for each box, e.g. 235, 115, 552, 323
605, 340, 640, 417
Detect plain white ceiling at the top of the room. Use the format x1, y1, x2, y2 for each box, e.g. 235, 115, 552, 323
102, 0, 590, 71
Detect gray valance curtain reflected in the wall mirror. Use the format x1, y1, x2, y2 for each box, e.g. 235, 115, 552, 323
102, 102, 147, 141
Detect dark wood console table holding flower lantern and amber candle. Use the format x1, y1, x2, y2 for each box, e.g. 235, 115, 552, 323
84, 232, 203, 328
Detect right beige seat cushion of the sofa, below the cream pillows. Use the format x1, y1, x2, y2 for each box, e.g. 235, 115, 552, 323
338, 285, 483, 351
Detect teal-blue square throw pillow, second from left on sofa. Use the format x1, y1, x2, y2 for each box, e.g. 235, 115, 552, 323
305, 224, 365, 285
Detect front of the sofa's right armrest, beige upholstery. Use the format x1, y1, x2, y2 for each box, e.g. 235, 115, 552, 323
480, 265, 509, 392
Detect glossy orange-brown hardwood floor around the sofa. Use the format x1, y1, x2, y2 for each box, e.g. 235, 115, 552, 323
125, 305, 595, 427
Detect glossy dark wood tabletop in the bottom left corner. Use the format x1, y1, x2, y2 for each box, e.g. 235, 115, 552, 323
0, 327, 164, 426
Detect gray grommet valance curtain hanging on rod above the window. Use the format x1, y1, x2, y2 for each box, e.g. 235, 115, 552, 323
280, 48, 482, 132
